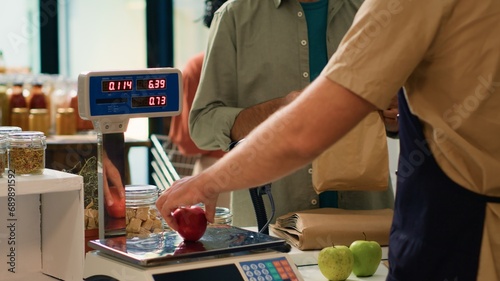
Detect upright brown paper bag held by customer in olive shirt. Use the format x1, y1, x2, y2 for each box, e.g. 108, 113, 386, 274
312, 111, 389, 191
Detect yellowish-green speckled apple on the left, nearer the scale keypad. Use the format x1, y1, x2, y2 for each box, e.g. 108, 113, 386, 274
318, 245, 354, 281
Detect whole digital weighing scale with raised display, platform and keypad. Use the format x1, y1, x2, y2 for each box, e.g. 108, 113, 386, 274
78, 68, 303, 281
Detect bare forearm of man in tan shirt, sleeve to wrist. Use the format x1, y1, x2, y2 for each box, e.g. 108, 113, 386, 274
207, 77, 376, 195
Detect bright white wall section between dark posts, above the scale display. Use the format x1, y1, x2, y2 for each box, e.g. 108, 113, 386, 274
66, 0, 147, 77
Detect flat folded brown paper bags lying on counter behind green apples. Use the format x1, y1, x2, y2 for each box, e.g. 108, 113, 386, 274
270, 208, 394, 250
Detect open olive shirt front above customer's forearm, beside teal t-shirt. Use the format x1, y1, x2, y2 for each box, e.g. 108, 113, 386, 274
216, 0, 362, 107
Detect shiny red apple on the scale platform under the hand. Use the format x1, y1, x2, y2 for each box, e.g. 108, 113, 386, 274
173, 203, 207, 241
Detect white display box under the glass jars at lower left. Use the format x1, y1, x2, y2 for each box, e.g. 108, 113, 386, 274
0, 169, 84, 281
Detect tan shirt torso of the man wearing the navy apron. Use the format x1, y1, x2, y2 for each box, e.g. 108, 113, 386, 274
407, 0, 500, 196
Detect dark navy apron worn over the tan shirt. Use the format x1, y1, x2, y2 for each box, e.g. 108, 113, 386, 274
387, 93, 500, 281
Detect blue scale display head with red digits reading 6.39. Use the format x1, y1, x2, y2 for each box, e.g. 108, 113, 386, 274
78, 68, 182, 120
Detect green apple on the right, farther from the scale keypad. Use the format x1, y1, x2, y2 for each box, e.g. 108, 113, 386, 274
349, 236, 382, 277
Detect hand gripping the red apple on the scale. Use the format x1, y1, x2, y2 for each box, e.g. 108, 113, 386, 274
156, 174, 219, 231
